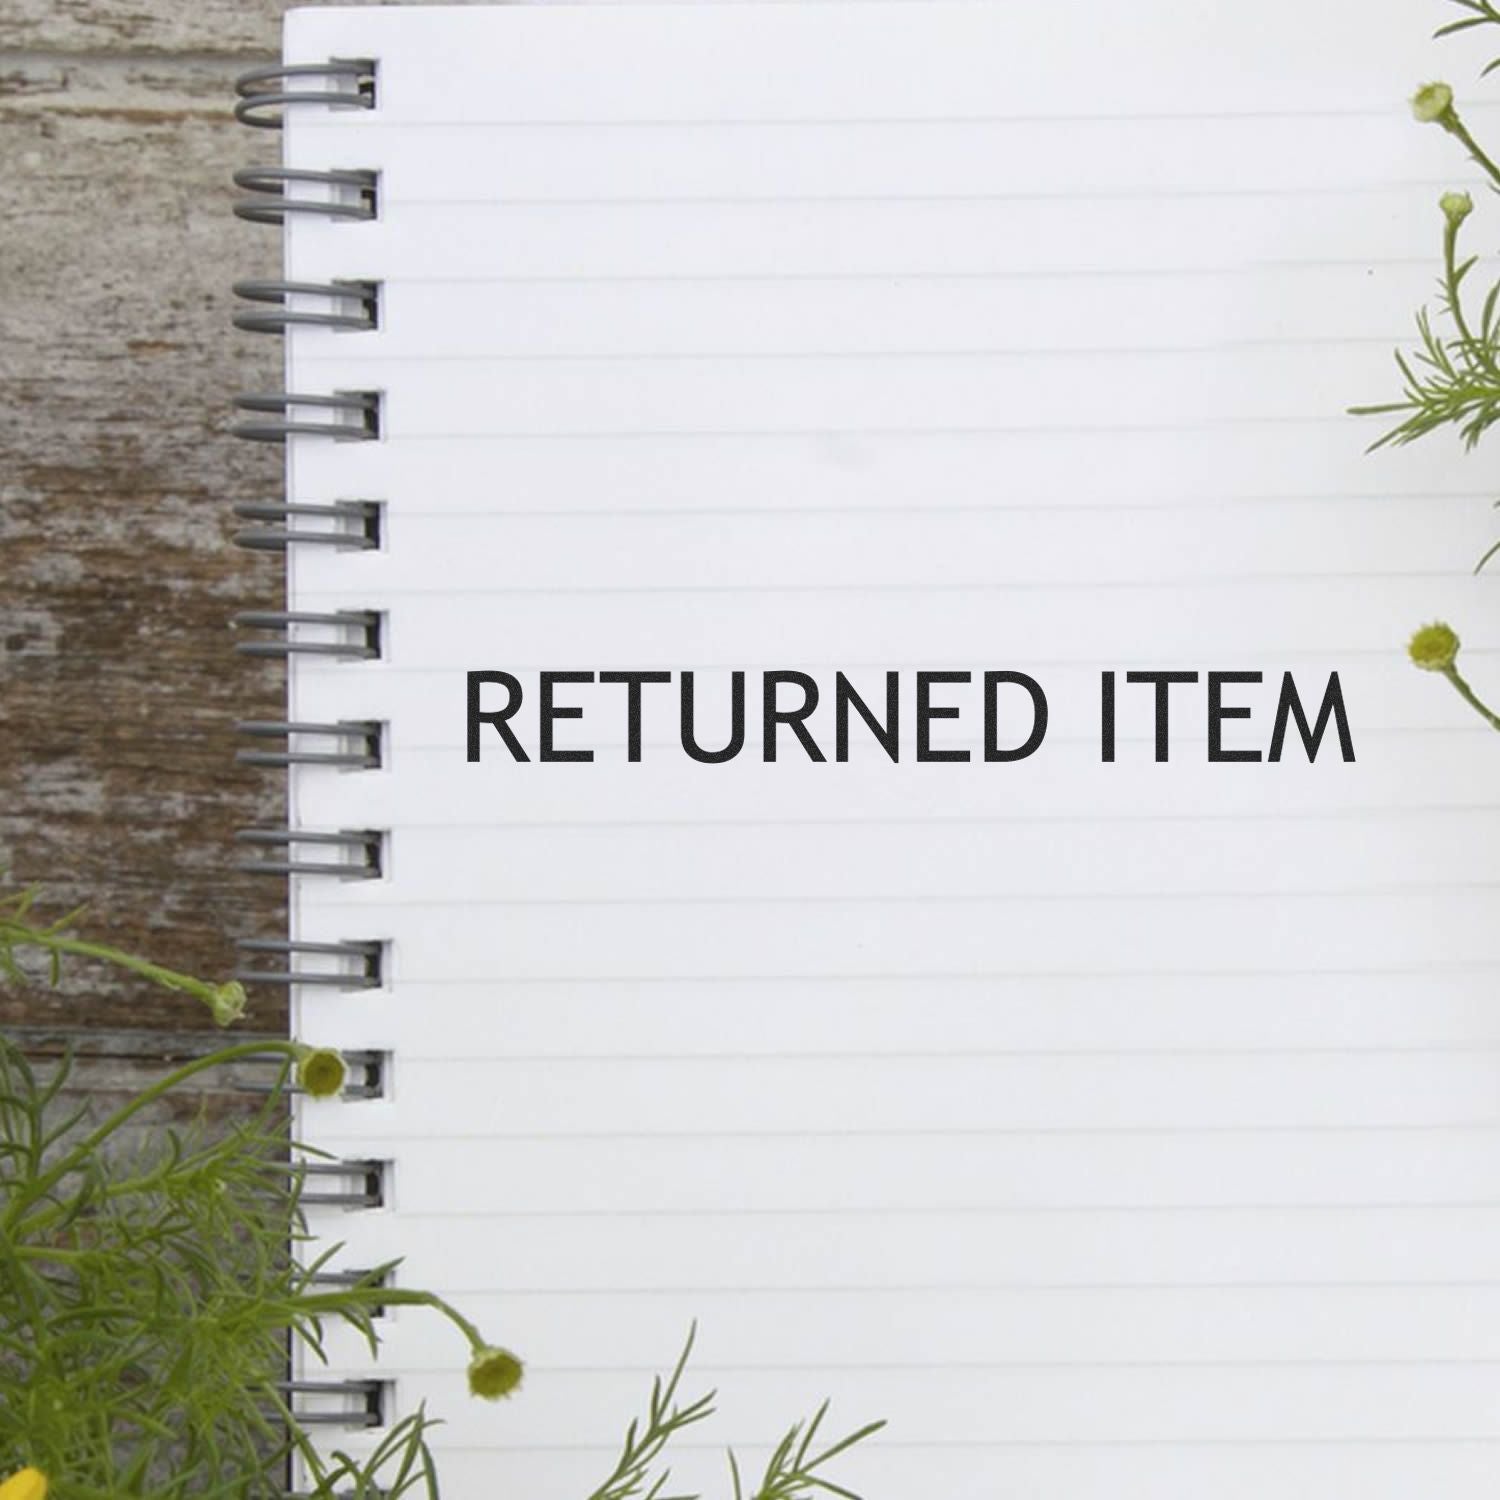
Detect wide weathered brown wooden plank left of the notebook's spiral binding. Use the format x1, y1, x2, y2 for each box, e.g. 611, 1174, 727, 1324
0, 61, 282, 1029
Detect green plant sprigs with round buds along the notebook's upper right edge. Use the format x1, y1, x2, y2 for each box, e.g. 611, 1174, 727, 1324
1350, 0, 1500, 729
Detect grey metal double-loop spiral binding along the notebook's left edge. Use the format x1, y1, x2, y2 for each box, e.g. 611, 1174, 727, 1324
233, 57, 389, 1452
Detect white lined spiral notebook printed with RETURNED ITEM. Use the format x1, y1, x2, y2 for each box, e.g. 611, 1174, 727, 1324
225, 0, 1500, 1500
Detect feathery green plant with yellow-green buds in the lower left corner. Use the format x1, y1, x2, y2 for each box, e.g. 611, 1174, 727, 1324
0, 891, 521, 1500
